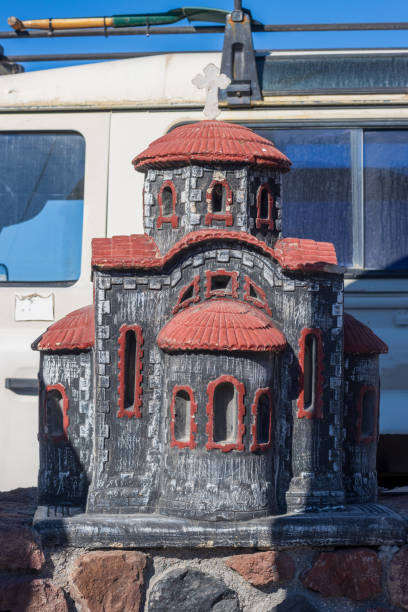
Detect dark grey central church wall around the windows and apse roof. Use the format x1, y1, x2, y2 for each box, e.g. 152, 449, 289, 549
88, 240, 344, 519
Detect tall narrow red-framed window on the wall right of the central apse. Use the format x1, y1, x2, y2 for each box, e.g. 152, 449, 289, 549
298, 328, 323, 419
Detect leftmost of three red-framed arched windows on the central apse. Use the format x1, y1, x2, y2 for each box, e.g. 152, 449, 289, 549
170, 385, 197, 448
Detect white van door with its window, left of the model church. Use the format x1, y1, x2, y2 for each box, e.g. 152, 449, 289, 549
0, 112, 110, 490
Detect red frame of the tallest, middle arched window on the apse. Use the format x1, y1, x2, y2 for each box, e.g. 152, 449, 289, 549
205, 375, 245, 453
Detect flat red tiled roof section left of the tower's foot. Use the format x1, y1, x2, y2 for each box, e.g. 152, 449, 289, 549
92, 234, 160, 269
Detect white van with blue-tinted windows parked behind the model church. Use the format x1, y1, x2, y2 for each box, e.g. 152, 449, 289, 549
0, 50, 408, 490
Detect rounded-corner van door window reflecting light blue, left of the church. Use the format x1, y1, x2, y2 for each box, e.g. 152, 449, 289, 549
0, 132, 85, 282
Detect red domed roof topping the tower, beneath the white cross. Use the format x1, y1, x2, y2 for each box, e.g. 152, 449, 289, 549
132, 120, 291, 172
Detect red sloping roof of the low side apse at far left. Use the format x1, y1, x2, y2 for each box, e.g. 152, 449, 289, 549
31, 304, 95, 351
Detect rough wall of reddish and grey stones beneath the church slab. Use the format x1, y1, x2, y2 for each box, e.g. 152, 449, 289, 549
0, 492, 408, 612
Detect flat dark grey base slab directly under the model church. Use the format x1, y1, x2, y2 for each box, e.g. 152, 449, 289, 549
34, 504, 407, 549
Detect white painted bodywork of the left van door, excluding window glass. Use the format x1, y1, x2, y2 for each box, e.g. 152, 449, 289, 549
0, 113, 110, 490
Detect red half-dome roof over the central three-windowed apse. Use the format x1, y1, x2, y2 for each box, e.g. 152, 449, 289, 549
157, 299, 286, 351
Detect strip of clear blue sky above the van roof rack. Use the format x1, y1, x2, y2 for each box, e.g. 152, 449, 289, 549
0, 0, 408, 70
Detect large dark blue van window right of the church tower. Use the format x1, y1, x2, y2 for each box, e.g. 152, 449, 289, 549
258, 127, 408, 272
